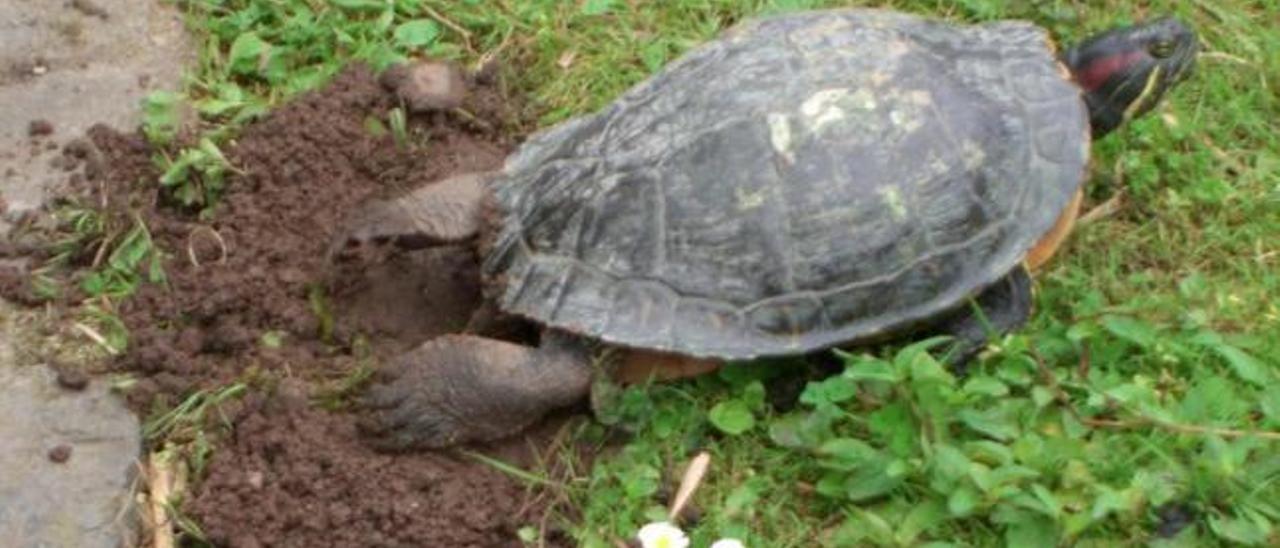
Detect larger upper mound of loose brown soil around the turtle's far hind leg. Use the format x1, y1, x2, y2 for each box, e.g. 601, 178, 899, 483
115, 67, 511, 405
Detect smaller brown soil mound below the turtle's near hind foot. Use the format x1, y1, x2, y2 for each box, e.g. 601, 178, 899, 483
187, 386, 567, 548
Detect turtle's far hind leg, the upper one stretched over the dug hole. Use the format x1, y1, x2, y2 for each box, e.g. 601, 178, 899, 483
329, 172, 494, 259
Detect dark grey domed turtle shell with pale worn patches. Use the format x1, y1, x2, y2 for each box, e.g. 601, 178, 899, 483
484, 10, 1089, 359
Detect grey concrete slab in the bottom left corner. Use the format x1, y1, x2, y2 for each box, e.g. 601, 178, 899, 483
0, 358, 142, 548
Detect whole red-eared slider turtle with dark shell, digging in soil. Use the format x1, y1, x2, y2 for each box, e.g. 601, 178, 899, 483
338, 10, 1197, 447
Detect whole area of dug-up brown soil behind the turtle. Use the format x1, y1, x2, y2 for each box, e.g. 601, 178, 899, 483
5, 65, 567, 547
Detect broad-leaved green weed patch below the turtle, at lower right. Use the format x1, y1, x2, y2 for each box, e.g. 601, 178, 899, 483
580, 328, 1280, 545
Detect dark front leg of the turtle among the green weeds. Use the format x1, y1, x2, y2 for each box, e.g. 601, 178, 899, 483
937, 266, 1034, 373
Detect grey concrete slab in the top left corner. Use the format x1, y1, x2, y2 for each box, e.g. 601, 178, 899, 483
0, 0, 191, 227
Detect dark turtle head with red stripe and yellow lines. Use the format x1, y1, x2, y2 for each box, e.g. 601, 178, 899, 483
1062, 17, 1199, 137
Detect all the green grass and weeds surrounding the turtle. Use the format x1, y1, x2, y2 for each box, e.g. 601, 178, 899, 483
135, 0, 1280, 547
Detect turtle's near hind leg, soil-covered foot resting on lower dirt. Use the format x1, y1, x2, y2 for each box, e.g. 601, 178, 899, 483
361, 333, 593, 451
